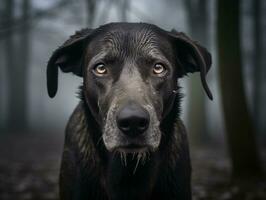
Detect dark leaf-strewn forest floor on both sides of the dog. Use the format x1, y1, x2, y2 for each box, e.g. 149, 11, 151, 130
0, 134, 266, 200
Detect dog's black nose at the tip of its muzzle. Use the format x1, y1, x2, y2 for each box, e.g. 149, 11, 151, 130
116, 103, 150, 137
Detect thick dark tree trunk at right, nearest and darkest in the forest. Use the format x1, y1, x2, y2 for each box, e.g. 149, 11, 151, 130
217, 0, 261, 178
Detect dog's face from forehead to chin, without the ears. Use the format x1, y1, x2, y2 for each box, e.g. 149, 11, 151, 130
84, 25, 181, 151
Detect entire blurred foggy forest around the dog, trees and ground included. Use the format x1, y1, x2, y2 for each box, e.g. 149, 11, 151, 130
0, 0, 266, 200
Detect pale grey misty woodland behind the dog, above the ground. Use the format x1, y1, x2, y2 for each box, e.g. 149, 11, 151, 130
0, 0, 266, 141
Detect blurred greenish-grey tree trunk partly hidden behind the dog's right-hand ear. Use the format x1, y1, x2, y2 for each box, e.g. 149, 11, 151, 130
184, 0, 209, 146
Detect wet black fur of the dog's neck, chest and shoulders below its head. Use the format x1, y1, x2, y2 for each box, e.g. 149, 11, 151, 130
60, 92, 191, 200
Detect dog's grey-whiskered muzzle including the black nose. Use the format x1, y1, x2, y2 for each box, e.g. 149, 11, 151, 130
102, 99, 161, 153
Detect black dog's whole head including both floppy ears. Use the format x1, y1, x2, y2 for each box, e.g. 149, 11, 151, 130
47, 23, 212, 155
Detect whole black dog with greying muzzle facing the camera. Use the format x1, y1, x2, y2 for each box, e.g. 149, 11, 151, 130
47, 23, 212, 200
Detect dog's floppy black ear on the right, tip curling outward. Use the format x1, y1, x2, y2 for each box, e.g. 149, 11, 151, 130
169, 29, 213, 100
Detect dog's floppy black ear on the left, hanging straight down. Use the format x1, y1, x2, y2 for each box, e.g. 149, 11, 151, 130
46, 29, 92, 98
